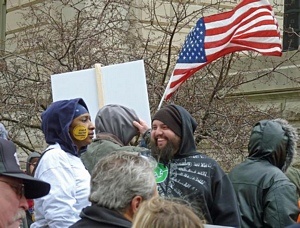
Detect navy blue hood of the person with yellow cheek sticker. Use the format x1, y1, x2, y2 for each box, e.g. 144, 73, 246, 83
42, 98, 88, 156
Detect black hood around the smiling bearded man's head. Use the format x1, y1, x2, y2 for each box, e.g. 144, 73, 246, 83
171, 104, 198, 158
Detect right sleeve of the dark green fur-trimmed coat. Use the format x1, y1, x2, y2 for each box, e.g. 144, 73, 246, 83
263, 180, 299, 227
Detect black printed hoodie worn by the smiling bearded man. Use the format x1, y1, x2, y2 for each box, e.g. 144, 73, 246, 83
156, 105, 240, 227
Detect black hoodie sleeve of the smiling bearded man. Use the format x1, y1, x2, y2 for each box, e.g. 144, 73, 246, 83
211, 166, 241, 227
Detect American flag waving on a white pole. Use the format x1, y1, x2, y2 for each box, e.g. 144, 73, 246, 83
164, 0, 282, 100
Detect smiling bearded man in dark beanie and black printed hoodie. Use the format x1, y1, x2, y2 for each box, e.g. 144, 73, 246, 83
135, 105, 240, 227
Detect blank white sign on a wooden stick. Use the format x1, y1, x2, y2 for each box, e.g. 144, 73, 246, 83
51, 60, 151, 127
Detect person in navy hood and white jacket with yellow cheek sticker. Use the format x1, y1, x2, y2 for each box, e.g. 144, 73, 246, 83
31, 98, 95, 228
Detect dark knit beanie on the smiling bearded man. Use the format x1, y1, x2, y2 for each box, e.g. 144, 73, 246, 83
152, 105, 182, 137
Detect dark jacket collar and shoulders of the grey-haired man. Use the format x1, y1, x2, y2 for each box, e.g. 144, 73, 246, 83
70, 205, 132, 228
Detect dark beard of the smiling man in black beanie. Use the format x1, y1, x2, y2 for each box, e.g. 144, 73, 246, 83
151, 136, 180, 163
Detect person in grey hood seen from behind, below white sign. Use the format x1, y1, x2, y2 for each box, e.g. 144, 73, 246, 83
81, 104, 146, 173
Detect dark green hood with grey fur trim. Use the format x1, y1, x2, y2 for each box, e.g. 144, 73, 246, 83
248, 119, 298, 172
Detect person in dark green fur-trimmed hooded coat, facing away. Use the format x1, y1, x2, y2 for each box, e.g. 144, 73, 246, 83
229, 119, 299, 228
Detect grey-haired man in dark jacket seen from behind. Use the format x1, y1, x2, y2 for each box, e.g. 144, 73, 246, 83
70, 151, 158, 228
